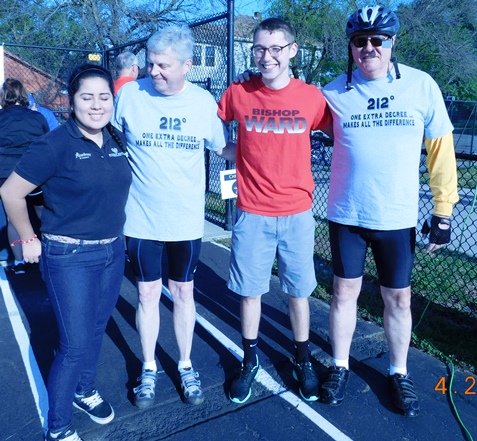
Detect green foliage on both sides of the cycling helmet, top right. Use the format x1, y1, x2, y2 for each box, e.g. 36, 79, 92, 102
267, 0, 477, 96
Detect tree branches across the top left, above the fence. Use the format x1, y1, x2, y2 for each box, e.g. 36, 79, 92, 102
0, 0, 223, 50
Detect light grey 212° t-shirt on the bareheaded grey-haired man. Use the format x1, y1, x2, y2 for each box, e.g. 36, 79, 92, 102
112, 78, 228, 242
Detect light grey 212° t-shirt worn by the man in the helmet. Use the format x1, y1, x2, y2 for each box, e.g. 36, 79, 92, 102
323, 64, 453, 230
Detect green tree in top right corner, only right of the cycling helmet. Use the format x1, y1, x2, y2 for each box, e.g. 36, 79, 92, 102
396, 0, 477, 100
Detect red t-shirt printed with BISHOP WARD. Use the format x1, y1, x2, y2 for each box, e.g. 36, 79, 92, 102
219, 76, 331, 216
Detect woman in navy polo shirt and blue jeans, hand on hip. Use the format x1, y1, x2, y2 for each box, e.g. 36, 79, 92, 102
1, 64, 131, 441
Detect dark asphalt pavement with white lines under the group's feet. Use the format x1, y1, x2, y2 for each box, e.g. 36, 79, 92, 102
0, 224, 477, 441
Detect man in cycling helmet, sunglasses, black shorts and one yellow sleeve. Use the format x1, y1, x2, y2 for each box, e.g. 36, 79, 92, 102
320, 6, 459, 417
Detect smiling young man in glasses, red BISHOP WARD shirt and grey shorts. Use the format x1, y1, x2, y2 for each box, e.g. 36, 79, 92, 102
219, 18, 331, 403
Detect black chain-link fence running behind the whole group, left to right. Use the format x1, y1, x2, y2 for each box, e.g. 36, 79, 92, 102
3, 18, 477, 318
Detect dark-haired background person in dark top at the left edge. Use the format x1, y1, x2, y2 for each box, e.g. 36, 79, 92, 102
0, 78, 49, 274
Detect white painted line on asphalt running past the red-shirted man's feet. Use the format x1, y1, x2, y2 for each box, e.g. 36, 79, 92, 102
162, 286, 352, 441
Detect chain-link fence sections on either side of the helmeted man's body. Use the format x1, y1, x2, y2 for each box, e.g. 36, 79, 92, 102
311, 101, 477, 318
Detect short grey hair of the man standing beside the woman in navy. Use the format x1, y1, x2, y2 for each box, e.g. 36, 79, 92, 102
147, 26, 194, 63
